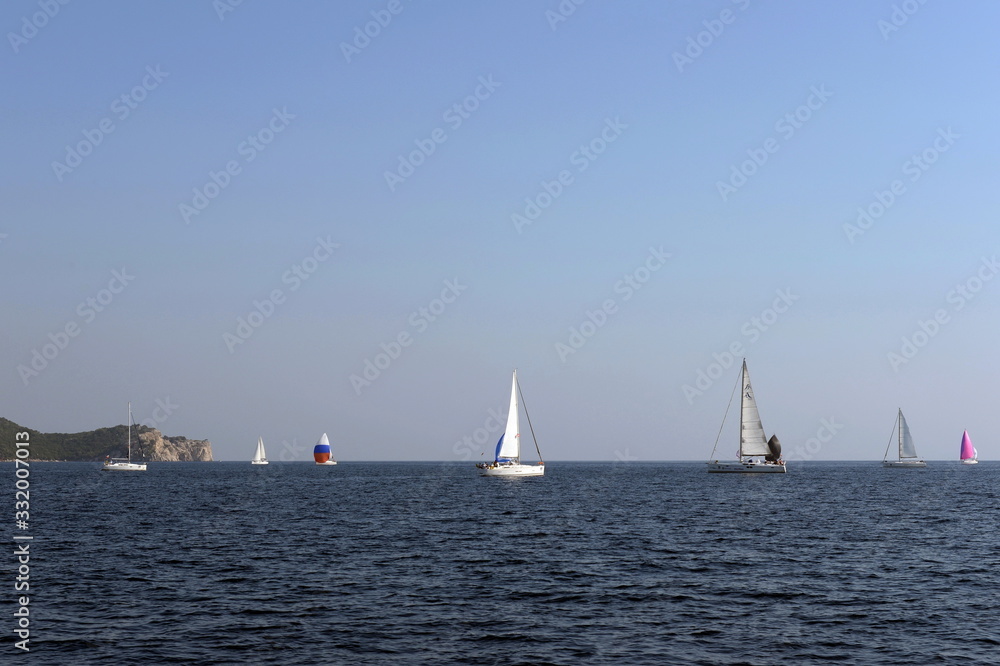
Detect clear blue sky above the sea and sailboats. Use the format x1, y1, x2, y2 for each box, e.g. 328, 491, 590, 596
0, 0, 1000, 461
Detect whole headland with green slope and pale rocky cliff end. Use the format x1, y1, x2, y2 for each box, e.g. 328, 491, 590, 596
0, 417, 212, 462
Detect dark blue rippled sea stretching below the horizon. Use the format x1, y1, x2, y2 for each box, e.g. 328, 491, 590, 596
0, 461, 1000, 665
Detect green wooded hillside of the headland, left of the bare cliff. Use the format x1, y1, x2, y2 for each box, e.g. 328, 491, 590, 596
0, 417, 149, 461
